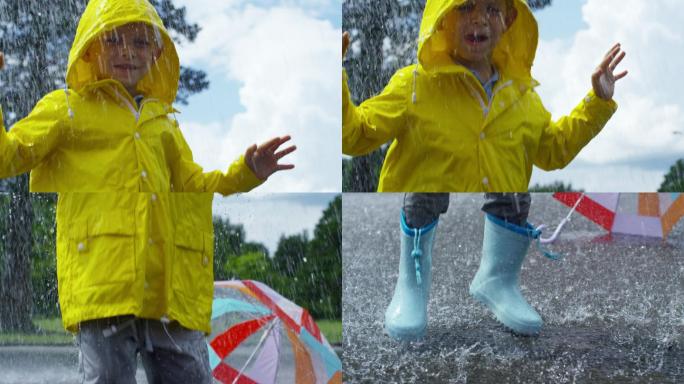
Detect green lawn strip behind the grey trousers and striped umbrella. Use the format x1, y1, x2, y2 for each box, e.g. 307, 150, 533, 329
0, 318, 342, 345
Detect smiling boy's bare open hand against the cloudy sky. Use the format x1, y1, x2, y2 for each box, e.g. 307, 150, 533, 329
245, 136, 297, 180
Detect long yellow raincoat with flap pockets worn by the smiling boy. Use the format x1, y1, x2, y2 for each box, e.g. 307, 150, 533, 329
0, 0, 262, 332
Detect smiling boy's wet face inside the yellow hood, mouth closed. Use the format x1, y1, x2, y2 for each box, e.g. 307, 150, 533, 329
84, 23, 162, 93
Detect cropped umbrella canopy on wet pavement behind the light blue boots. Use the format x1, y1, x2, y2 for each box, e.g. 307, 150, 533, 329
553, 192, 684, 238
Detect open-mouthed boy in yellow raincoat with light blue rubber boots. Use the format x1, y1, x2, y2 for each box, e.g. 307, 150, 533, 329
342, 0, 627, 338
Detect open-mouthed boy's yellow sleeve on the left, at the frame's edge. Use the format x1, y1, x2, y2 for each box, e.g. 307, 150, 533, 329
342, 68, 413, 156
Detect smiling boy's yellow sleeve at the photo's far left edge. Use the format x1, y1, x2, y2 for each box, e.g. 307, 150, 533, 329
0, 91, 68, 178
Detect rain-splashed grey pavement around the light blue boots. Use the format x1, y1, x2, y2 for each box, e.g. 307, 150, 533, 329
342, 194, 684, 383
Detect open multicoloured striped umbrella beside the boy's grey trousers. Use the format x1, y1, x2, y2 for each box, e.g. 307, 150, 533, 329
207, 280, 342, 384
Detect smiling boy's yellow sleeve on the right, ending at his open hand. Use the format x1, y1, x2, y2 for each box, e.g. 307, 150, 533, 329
166, 125, 264, 196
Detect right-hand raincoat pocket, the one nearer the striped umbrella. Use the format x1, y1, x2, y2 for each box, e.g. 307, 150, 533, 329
171, 226, 214, 309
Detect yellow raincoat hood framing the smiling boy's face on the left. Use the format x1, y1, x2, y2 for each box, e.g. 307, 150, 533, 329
66, 0, 180, 104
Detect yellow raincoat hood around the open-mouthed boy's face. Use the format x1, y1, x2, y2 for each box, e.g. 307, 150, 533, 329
418, 0, 539, 80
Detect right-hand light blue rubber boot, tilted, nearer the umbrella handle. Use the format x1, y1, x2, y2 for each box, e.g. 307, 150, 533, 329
470, 215, 542, 335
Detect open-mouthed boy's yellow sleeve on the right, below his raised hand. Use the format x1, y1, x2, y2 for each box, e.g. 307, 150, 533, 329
534, 90, 617, 171
